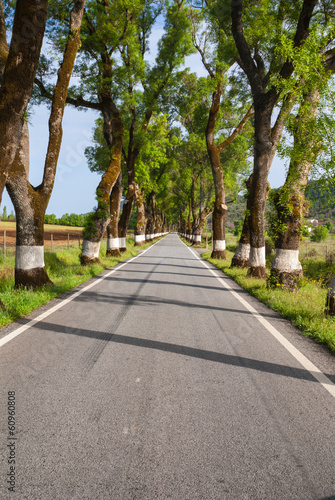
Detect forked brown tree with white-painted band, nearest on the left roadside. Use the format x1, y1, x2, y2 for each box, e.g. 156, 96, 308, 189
6, 0, 85, 288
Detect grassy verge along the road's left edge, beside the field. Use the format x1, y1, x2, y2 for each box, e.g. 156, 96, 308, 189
0, 238, 156, 327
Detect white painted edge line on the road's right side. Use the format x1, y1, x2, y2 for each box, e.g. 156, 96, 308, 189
185, 245, 335, 398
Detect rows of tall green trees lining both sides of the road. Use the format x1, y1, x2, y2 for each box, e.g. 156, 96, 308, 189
0, 0, 335, 300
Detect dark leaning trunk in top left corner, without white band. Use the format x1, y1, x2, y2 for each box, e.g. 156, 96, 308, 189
0, 0, 48, 203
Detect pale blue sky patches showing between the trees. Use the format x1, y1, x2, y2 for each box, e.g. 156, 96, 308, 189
0, 28, 285, 217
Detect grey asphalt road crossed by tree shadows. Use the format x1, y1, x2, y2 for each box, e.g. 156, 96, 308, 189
0, 234, 335, 500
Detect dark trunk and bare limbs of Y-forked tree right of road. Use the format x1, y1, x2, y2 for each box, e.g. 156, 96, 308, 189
231, 0, 317, 278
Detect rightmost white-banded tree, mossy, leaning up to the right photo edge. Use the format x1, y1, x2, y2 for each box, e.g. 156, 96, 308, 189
270, 50, 335, 289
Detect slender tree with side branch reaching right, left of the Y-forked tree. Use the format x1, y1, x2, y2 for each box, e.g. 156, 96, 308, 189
193, 2, 253, 259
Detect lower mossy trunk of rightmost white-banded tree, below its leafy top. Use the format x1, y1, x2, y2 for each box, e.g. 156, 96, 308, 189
269, 90, 320, 289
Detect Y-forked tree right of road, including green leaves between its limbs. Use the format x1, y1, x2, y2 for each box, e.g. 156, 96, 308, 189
231, 0, 317, 277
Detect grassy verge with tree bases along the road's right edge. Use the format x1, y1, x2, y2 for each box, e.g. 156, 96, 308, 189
197, 236, 335, 353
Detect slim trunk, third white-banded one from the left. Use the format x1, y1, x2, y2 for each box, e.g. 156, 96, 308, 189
106, 172, 122, 257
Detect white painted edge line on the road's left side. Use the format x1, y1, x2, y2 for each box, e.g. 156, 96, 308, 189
0, 240, 161, 347
